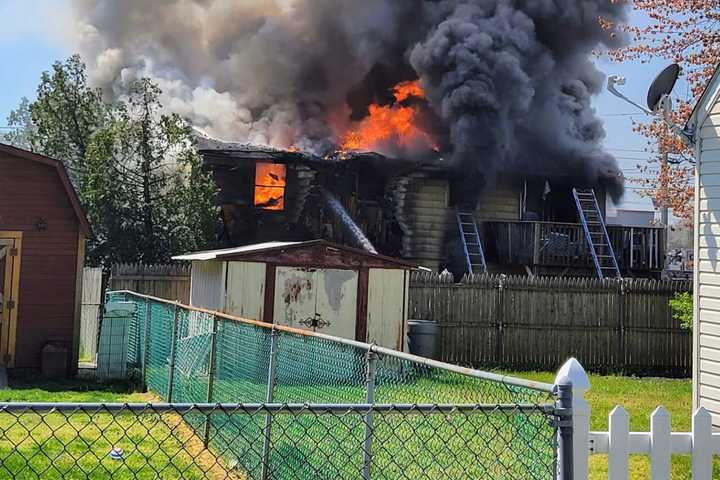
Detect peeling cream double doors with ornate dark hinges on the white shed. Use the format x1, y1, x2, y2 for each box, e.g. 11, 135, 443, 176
274, 267, 358, 339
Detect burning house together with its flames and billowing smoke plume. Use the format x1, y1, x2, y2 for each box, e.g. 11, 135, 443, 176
70, 0, 664, 277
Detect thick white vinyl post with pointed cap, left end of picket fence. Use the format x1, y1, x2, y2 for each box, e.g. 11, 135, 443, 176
555, 358, 590, 480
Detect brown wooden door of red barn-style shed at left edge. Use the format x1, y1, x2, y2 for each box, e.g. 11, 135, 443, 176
0, 236, 20, 366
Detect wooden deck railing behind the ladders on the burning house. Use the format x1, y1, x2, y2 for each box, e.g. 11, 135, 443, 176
483, 221, 665, 271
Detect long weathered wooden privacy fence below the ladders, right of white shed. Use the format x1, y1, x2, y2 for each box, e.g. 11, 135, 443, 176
409, 272, 692, 376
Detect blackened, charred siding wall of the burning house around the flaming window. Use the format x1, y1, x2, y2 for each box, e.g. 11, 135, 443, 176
200, 146, 616, 273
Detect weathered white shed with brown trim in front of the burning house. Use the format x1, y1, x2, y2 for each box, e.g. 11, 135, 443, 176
175, 240, 413, 350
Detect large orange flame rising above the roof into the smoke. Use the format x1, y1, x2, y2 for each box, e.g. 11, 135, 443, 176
341, 80, 437, 150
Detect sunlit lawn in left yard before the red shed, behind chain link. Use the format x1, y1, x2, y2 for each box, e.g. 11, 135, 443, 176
0, 381, 233, 480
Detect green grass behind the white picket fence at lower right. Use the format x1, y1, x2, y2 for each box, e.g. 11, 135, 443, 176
513, 372, 720, 480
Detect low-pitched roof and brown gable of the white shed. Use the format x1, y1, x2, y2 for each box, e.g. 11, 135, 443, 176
173, 240, 417, 269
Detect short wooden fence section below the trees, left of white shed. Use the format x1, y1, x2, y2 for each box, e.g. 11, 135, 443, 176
110, 263, 190, 304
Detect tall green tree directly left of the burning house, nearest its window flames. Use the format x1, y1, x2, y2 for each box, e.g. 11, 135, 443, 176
85, 79, 219, 263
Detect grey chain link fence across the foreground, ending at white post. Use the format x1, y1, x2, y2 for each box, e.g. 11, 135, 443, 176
0, 404, 555, 480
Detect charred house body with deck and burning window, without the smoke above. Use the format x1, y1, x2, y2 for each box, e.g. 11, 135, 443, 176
200, 133, 665, 276
